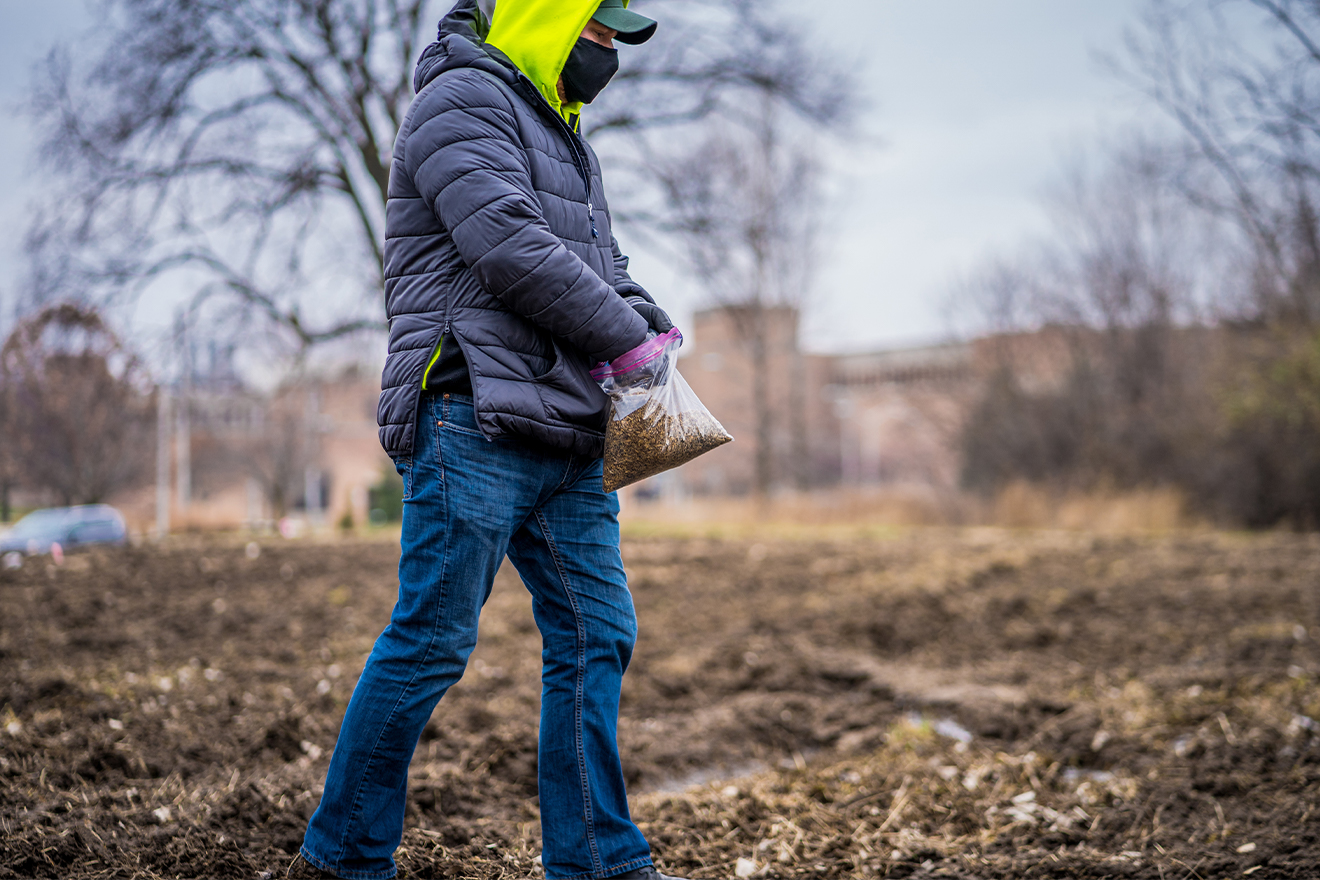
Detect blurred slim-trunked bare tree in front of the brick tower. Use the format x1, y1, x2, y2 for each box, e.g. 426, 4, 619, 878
595, 0, 859, 496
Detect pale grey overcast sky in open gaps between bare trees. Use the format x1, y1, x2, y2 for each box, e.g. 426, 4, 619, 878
0, 0, 1166, 351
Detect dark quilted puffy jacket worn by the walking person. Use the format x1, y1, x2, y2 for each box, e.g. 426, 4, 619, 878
376, 0, 649, 455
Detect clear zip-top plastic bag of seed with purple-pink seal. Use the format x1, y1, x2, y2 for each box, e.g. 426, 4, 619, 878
591, 329, 733, 492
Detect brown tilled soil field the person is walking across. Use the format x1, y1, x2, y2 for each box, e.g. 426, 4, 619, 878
0, 530, 1320, 880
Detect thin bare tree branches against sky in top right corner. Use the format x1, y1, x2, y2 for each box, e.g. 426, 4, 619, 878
1111, 0, 1320, 325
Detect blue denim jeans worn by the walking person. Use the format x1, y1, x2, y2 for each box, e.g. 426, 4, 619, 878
302, 394, 651, 880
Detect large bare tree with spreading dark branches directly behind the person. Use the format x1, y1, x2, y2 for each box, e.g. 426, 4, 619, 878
29, 0, 855, 347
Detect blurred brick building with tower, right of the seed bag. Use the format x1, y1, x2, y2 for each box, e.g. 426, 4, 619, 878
668, 307, 1050, 495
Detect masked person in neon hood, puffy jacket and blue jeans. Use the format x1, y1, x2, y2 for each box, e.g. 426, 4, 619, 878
285, 0, 672, 880
